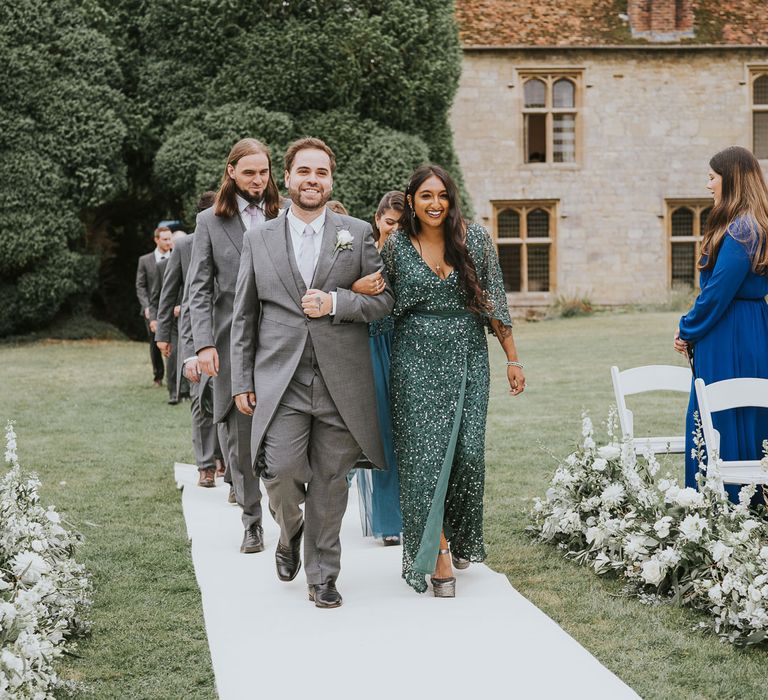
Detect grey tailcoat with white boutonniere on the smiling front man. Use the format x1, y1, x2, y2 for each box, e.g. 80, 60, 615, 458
232, 209, 394, 467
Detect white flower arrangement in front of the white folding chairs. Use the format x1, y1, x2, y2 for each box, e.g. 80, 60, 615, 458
529, 408, 768, 644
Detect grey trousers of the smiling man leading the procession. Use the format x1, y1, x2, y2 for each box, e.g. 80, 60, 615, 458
262, 374, 361, 584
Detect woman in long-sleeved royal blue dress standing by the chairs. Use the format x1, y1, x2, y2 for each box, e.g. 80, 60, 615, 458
674, 146, 768, 501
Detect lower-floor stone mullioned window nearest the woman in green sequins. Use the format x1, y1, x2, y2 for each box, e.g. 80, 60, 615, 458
493, 201, 557, 293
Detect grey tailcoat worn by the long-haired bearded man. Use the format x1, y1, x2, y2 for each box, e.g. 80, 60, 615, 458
189, 207, 244, 423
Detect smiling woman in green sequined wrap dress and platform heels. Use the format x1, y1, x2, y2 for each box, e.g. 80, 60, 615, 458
382, 165, 525, 597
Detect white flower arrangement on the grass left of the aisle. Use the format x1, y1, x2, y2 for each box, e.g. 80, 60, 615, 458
0, 423, 90, 700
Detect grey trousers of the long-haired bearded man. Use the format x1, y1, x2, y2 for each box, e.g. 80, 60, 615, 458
225, 406, 261, 529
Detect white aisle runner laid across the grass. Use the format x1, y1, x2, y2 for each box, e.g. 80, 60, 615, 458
175, 463, 638, 700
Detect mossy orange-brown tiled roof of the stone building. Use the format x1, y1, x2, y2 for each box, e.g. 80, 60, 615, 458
455, 0, 768, 48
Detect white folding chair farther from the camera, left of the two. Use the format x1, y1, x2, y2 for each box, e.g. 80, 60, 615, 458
611, 365, 691, 454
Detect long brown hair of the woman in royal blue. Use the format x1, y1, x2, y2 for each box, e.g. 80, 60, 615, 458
699, 146, 768, 274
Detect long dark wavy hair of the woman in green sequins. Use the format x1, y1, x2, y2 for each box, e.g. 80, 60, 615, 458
400, 164, 491, 314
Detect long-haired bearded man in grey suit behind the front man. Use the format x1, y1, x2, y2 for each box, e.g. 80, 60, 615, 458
189, 139, 280, 554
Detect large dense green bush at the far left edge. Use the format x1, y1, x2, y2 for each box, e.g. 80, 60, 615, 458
0, 0, 126, 335
